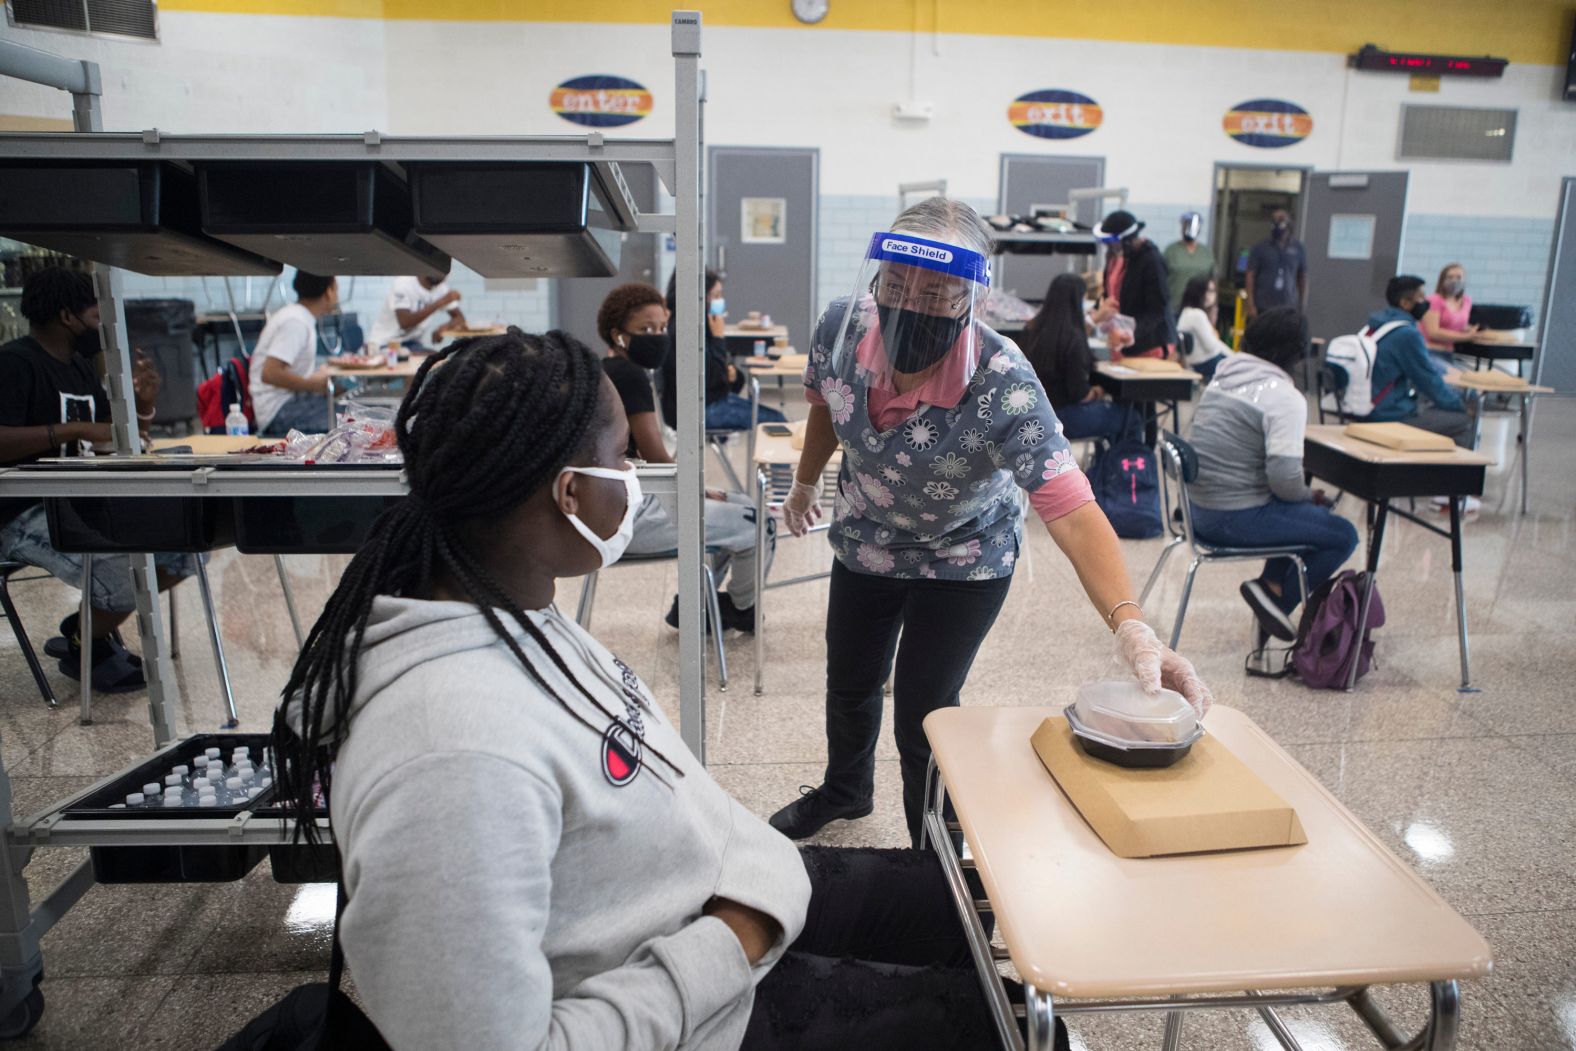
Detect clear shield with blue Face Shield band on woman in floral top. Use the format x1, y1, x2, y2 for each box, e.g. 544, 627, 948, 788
832, 233, 990, 389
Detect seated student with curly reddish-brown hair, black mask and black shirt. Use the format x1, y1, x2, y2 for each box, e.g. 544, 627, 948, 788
596, 284, 777, 632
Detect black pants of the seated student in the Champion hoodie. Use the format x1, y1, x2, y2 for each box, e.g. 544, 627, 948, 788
739, 846, 999, 1051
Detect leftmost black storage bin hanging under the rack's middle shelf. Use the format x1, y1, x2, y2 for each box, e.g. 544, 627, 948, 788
44, 496, 235, 555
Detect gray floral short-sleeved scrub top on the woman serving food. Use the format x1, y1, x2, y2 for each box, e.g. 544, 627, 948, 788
804, 301, 1087, 580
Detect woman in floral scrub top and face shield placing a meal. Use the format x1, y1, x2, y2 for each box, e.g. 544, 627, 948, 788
771, 197, 1210, 841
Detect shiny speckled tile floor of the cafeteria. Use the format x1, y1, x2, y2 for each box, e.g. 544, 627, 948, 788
0, 402, 1576, 1051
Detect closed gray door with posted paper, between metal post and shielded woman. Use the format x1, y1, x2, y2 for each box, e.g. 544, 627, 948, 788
706, 147, 821, 351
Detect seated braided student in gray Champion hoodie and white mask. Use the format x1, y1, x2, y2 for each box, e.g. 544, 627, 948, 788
274, 331, 1067, 1051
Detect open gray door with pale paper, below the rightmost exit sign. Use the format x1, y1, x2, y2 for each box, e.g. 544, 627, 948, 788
1300, 172, 1406, 339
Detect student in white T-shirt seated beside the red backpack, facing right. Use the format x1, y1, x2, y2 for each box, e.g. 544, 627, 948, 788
247, 269, 339, 438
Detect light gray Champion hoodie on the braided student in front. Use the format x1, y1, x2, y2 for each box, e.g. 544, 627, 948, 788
321, 597, 810, 1051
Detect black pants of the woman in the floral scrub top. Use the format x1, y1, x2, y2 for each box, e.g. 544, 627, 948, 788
823, 563, 1012, 845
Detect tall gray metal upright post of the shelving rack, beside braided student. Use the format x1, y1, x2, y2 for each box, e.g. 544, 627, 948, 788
671, 11, 706, 763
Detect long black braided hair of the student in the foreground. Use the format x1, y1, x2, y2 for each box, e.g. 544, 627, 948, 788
273, 328, 679, 841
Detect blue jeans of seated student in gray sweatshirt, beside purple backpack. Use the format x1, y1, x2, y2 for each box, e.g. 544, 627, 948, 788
1193, 500, 1357, 613
